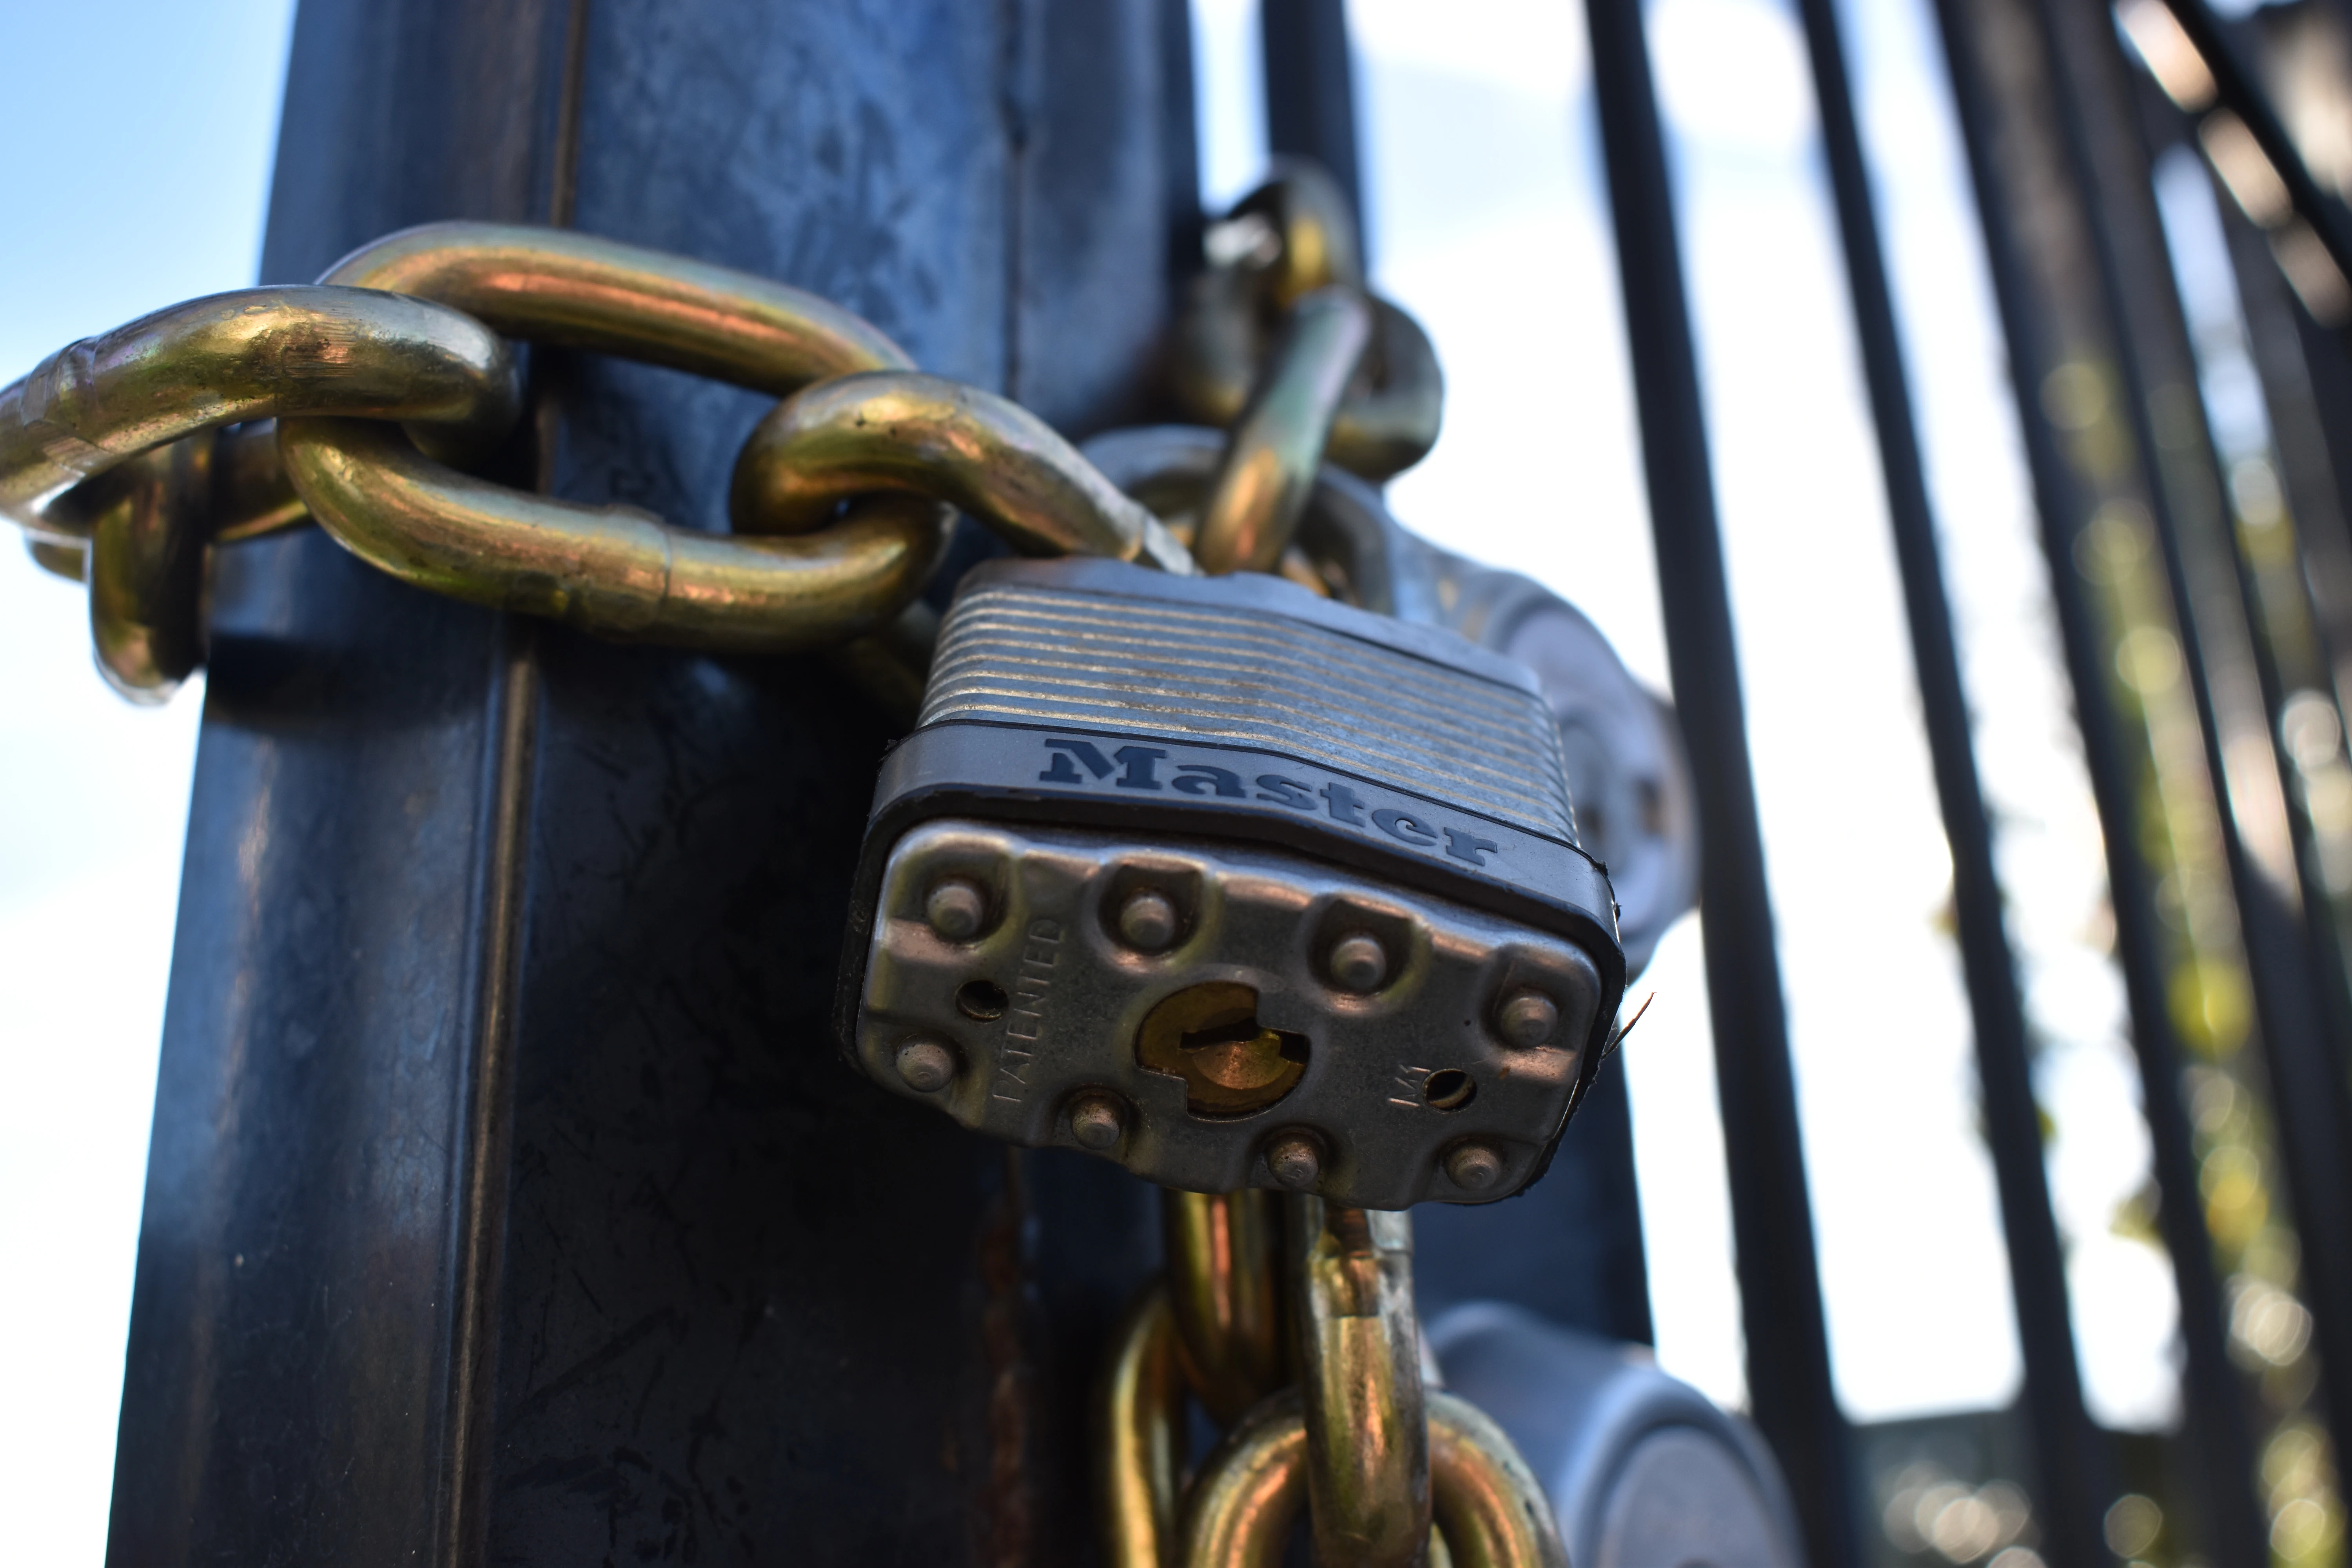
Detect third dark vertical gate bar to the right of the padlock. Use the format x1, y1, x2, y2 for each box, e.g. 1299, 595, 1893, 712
1936, 0, 2270, 1568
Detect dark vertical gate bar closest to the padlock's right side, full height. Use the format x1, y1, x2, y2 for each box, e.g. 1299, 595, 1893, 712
1585, 0, 1858, 1568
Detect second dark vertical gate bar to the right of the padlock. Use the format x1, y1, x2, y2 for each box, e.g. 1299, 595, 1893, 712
1799, 0, 2117, 1568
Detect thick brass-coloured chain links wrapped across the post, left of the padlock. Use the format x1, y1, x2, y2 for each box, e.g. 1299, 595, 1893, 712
0, 223, 1192, 701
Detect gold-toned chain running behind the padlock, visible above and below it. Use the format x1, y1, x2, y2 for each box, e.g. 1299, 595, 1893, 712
1098, 167, 1566, 1568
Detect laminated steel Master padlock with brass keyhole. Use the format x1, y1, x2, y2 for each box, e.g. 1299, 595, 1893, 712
837, 559, 1625, 1208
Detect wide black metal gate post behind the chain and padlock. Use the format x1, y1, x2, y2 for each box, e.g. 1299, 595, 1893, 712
108, 0, 1192, 1568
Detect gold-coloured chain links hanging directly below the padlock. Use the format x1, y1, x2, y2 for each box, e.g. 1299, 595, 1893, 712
1096, 1192, 1566, 1568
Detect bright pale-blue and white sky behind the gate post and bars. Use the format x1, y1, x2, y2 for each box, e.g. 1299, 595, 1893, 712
0, 0, 2178, 1563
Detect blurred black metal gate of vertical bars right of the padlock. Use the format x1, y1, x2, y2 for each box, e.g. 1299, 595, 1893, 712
1588, 0, 2352, 1563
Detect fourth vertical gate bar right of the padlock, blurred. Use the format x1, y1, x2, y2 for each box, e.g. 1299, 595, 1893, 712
2042, 0, 2352, 1453
